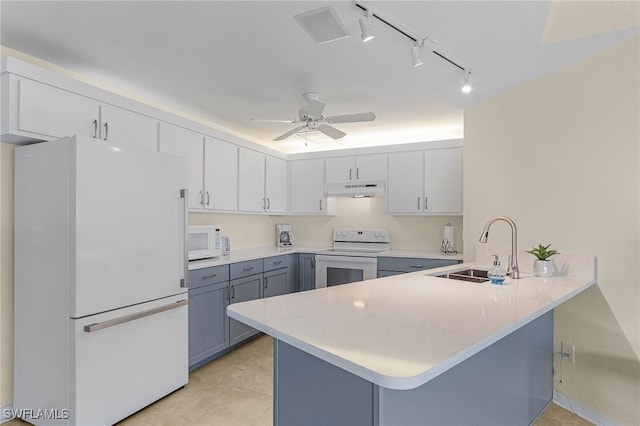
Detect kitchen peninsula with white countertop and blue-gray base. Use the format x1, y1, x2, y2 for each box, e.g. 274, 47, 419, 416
228, 257, 596, 425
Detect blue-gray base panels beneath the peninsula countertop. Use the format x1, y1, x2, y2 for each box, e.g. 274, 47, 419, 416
274, 311, 553, 426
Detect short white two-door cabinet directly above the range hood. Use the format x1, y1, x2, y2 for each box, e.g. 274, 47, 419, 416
325, 154, 387, 183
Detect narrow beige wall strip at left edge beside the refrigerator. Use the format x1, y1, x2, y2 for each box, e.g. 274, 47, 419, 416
0, 143, 14, 407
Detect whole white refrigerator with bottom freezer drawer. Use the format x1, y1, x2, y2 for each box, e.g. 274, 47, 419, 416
13, 137, 188, 425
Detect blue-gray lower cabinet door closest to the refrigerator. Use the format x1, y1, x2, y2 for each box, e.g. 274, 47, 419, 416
189, 281, 229, 366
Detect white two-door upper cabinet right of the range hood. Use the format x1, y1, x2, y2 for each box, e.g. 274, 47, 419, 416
387, 148, 462, 215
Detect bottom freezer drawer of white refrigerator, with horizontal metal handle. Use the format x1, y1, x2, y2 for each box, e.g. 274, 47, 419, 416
70, 293, 189, 425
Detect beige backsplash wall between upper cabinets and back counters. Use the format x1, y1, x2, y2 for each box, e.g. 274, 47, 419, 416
189, 198, 462, 252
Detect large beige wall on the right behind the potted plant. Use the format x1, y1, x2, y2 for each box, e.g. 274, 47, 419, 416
464, 38, 640, 425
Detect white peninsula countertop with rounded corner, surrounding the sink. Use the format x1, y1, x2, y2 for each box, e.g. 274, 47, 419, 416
228, 256, 595, 389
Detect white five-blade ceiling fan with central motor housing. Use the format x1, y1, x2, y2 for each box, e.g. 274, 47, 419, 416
251, 93, 376, 141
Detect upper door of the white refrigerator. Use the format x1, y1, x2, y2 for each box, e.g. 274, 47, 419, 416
70, 139, 187, 318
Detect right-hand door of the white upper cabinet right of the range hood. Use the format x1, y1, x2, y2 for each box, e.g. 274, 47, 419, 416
424, 148, 462, 214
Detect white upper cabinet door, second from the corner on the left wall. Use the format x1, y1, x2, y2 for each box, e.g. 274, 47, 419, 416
238, 148, 267, 212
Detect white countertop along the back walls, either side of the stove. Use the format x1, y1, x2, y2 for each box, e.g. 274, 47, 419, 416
189, 246, 462, 271
